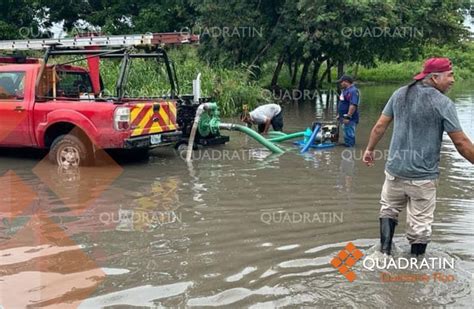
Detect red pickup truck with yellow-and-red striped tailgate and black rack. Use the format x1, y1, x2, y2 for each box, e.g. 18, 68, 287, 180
0, 35, 187, 167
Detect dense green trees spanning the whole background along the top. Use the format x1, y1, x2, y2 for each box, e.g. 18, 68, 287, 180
0, 0, 474, 113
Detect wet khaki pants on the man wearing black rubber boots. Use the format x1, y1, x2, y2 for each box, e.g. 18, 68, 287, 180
379, 171, 438, 244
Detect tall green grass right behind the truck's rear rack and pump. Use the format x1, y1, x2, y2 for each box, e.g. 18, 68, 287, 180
101, 47, 265, 116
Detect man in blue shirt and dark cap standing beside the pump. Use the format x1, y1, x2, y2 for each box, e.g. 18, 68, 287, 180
336, 75, 360, 147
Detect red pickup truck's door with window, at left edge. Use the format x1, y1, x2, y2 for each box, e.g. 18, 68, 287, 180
0, 66, 34, 146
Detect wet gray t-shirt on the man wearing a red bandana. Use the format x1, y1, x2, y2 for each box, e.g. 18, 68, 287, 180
382, 82, 462, 180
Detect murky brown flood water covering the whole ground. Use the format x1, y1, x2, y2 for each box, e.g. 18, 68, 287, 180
0, 82, 474, 308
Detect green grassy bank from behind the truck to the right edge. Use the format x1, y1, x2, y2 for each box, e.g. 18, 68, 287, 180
102, 43, 474, 117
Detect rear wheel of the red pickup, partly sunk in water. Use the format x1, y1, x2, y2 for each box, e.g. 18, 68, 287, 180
49, 134, 93, 168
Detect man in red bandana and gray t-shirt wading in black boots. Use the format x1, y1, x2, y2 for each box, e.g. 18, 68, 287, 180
363, 58, 474, 256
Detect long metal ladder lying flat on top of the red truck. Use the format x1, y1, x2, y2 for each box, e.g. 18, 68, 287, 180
0, 32, 199, 51
